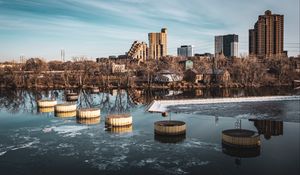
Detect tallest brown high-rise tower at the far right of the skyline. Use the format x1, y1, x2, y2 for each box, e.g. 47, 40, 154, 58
249, 10, 284, 58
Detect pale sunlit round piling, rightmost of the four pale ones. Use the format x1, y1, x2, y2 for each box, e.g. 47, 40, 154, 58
105, 114, 132, 127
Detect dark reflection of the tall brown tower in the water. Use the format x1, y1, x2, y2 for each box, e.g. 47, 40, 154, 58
249, 119, 283, 140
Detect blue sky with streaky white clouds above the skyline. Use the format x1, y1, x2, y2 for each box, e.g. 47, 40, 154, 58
0, 0, 300, 61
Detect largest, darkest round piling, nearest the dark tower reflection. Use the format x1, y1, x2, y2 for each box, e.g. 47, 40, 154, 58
222, 129, 260, 148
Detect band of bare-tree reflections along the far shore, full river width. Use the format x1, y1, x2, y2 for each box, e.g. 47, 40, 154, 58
0, 88, 299, 113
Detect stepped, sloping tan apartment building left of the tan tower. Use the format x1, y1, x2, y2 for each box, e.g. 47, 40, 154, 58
127, 41, 148, 62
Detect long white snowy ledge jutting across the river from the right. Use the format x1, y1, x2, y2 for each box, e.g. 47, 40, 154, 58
148, 95, 300, 112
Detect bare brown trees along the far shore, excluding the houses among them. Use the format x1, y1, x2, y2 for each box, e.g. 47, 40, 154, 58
0, 57, 300, 87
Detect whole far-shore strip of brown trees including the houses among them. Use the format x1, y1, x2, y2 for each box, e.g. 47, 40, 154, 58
0, 57, 300, 89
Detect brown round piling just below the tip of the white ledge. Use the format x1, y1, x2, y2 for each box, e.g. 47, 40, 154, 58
154, 120, 186, 136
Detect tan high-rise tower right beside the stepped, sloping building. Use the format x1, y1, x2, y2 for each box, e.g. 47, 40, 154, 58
148, 28, 168, 59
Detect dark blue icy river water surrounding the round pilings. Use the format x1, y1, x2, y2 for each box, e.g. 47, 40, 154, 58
0, 89, 300, 175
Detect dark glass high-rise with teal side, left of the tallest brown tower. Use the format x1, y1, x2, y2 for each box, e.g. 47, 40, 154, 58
215, 34, 239, 57
